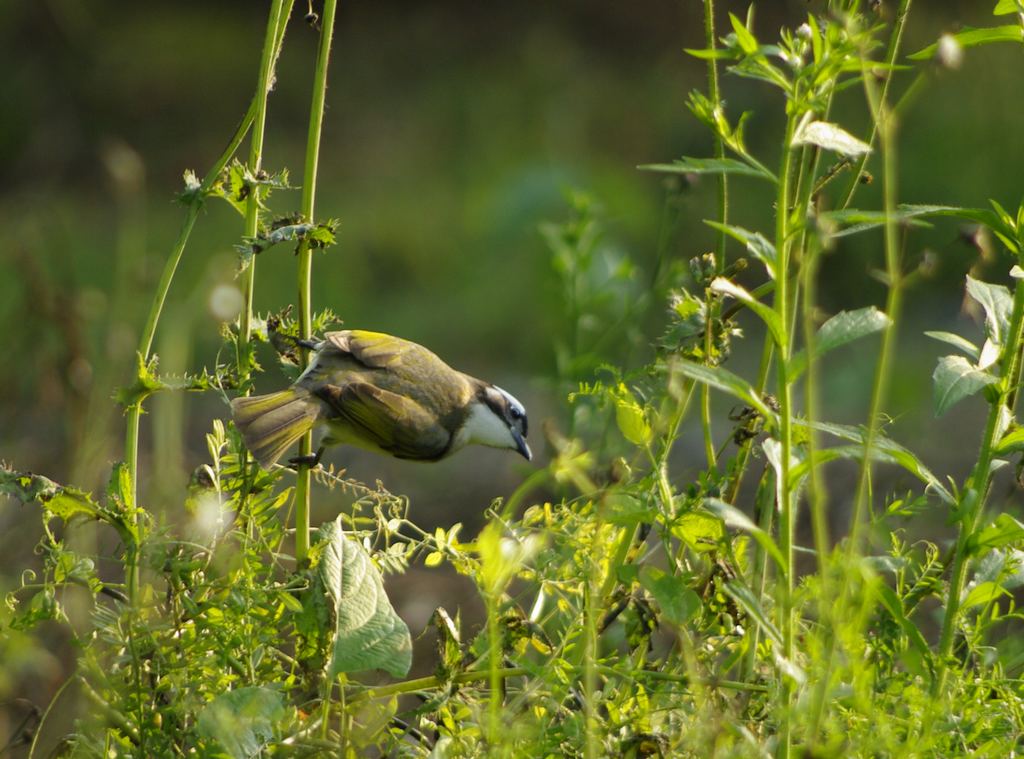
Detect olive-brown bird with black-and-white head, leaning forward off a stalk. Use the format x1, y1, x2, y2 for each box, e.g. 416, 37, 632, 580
231, 330, 532, 469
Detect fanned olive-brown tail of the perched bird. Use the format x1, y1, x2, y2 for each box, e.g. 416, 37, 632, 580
231, 387, 321, 469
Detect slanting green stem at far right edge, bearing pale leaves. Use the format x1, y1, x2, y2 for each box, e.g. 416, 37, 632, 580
933, 276, 1024, 694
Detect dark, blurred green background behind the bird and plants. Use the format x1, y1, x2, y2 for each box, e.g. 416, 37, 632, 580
0, 0, 1024, 740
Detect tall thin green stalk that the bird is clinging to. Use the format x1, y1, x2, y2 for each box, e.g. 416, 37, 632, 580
295, 0, 337, 563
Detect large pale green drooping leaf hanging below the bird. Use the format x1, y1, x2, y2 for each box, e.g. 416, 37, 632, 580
316, 516, 413, 679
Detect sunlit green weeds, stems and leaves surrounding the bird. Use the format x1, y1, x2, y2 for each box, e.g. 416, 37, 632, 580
6, 0, 1024, 757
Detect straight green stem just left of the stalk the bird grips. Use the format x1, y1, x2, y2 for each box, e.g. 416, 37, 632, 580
238, 0, 287, 381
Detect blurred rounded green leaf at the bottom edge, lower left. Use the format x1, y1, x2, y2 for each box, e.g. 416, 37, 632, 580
197, 687, 288, 759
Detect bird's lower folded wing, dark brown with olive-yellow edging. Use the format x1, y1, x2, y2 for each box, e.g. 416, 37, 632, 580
314, 382, 452, 460
